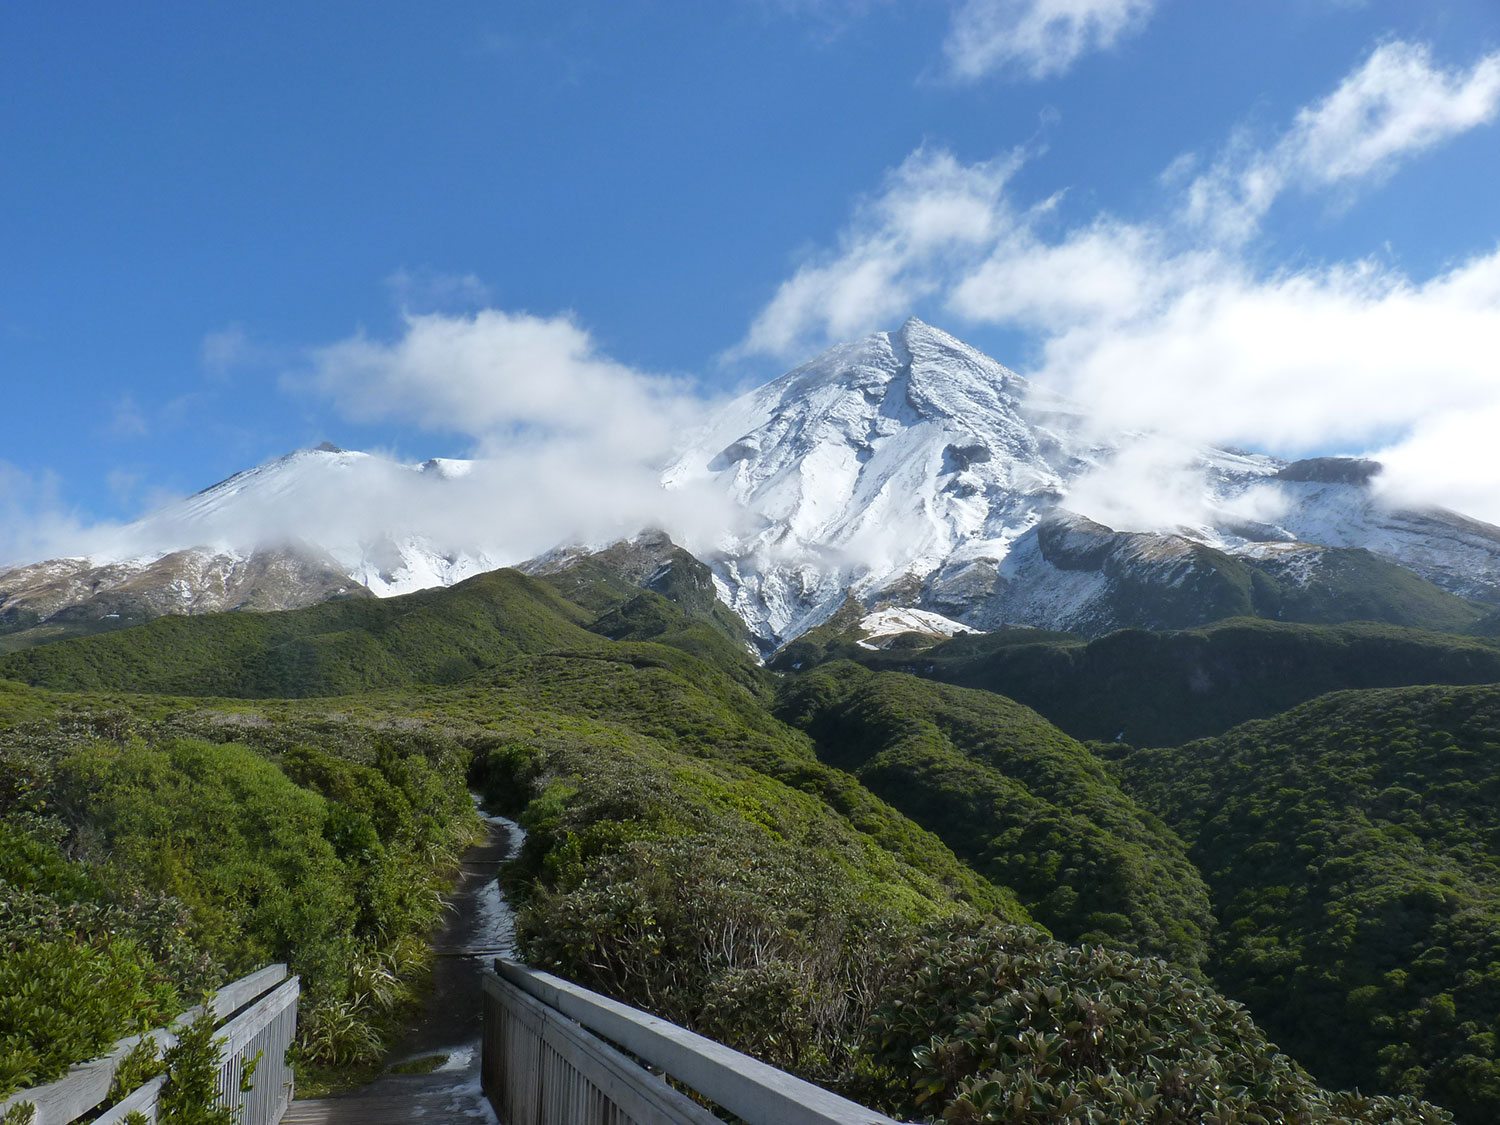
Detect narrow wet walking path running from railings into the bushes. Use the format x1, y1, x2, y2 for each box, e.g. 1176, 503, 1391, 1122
282, 816, 525, 1125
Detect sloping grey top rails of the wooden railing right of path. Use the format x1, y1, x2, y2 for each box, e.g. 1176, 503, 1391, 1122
486, 959, 897, 1125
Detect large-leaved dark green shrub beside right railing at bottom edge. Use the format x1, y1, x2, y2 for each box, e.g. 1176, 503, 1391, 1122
867, 926, 1451, 1125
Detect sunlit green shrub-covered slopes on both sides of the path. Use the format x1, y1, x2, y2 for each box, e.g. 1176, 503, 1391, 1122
0, 558, 1476, 1122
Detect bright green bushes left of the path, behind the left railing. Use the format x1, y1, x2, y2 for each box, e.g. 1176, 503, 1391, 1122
0, 705, 474, 1092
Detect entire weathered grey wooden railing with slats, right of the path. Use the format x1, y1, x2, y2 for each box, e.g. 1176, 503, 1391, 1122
482, 960, 894, 1125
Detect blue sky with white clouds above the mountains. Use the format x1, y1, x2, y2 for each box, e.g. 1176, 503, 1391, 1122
0, 0, 1500, 543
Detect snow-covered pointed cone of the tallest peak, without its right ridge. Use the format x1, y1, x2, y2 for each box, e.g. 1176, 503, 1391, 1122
663, 320, 1104, 638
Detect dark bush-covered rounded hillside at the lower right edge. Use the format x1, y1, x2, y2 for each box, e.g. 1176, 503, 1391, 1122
1119, 687, 1500, 1122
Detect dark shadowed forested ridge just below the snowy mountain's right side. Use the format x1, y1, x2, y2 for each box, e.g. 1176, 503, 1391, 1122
777, 618, 1500, 746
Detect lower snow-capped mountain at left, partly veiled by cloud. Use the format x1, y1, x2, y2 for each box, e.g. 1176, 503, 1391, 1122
0, 444, 503, 633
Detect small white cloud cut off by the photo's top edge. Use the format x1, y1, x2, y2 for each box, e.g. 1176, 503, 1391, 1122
945, 0, 1155, 80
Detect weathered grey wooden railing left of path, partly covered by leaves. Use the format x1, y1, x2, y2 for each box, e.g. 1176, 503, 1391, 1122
0, 965, 300, 1125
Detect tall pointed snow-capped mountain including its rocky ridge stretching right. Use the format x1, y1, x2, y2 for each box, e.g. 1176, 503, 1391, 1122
665, 320, 1500, 644
